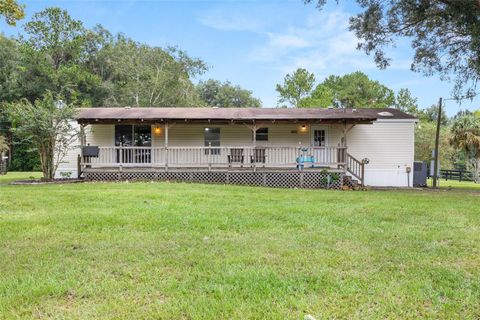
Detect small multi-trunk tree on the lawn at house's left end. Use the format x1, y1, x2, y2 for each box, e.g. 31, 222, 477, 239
7, 93, 78, 181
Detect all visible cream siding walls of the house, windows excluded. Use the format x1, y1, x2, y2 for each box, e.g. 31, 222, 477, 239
57, 120, 415, 187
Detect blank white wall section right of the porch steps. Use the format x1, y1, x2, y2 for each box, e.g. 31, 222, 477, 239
347, 120, 415, 187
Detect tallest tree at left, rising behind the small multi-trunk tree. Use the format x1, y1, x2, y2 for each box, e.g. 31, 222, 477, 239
20, 8, 106, 106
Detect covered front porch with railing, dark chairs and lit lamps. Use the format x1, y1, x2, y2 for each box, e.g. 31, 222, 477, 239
78, 109, 371, 186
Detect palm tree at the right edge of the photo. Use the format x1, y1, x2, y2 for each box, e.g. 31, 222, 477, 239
450, 115, 480, 183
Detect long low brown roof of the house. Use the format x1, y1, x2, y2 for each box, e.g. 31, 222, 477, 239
77, 107, 415, 124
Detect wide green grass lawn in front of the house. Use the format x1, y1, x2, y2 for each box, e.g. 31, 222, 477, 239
0, 175, 480, 319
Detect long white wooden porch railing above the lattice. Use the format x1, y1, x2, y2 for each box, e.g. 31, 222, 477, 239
82, 146, 346, 168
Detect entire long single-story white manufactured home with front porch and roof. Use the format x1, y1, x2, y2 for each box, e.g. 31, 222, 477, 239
57, 107, 416, 188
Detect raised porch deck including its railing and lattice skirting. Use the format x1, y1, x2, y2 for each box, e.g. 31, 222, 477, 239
80, 146, 364, 189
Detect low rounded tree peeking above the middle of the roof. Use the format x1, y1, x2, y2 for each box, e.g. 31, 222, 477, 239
197, 79, 262, 108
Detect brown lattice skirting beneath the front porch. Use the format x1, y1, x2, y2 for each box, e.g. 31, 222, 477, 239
84, 170, 344, 189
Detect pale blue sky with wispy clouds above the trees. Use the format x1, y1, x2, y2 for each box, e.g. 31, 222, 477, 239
0, 0, 480, 116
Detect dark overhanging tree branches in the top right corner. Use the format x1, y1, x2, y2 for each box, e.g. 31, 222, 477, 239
304, 0, 480, 98
